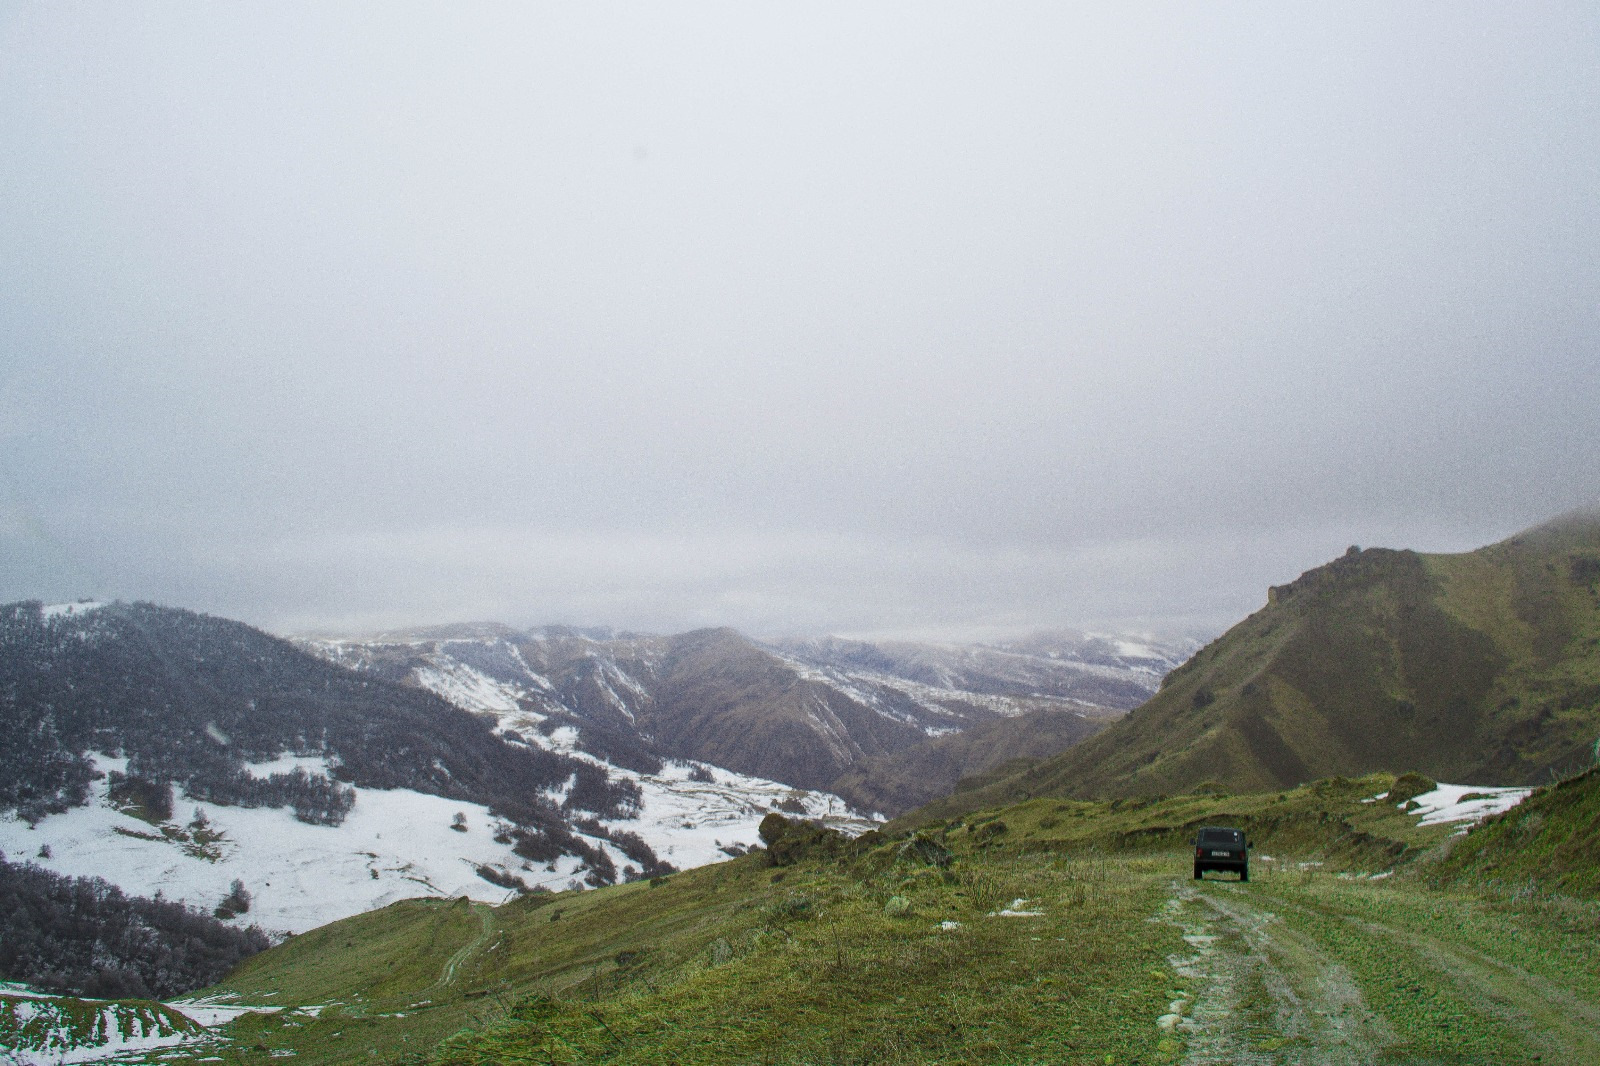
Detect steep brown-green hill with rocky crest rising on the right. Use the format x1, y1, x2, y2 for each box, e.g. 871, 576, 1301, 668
939, 517, 1600, 815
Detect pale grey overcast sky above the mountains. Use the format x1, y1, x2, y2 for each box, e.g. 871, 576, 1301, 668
0, 2, 1600, 634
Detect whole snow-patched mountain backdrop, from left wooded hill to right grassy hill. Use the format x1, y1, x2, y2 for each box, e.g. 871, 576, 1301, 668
0, 602, 1178, 930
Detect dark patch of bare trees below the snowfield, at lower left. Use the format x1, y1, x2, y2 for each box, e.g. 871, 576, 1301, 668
0, 855, 270, 999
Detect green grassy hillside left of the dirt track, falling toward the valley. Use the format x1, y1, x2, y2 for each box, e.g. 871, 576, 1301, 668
168, 853, 1179, 1063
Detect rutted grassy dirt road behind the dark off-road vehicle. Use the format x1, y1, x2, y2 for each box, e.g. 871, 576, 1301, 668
1162, 882, 1600, 1066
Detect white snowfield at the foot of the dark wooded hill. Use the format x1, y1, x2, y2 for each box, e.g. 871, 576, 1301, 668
0, 738, 872, 933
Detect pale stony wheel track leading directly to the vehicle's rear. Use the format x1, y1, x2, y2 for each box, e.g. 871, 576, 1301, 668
1162, 882, 1395, 1066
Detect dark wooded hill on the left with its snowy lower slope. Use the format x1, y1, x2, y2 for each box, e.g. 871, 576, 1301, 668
0, 603, 869, 932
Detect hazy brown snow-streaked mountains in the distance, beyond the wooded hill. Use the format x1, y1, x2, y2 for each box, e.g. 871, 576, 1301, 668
301, 624, 1198, 813
